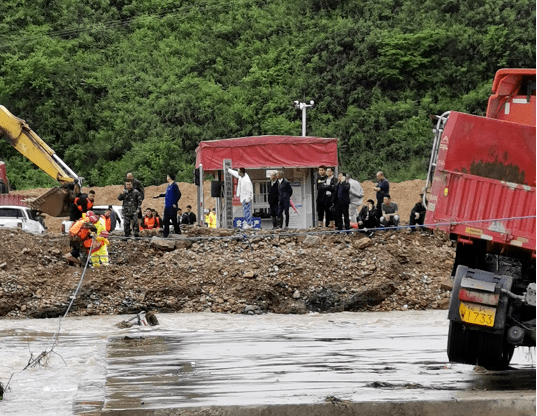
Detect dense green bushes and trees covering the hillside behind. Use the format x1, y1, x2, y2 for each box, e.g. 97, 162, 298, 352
0, 0, 536, 189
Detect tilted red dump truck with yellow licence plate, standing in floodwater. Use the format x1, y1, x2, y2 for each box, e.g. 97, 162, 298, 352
425, 69, 536, 369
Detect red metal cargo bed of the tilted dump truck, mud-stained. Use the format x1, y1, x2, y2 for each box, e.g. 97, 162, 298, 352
425, 112, 535, 251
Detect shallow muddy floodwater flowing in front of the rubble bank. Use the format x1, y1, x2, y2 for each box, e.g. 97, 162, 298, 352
0, 310, 535, 416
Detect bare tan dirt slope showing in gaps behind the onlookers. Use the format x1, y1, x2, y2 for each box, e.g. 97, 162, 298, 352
14, 179, 425, 233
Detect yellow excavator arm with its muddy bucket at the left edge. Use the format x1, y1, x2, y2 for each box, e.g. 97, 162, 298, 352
0, 105, 82, 217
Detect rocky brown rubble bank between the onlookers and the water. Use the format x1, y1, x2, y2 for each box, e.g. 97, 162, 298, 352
0, 227, 455, 318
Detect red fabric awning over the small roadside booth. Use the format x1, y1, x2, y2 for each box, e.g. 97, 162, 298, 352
196, 136, 338, 171
